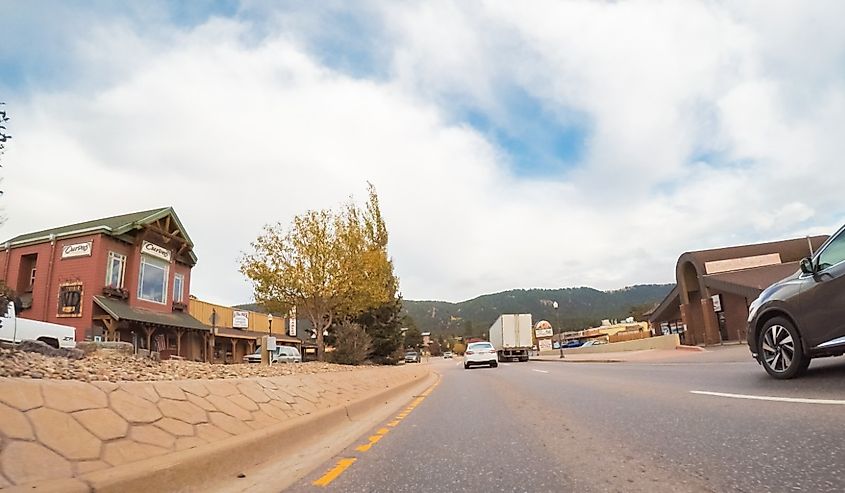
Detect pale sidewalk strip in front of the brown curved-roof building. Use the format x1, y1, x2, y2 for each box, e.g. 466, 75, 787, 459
531, 344, 752, 363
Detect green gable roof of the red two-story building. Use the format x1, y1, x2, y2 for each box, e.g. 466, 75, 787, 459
6, 207, 197, 262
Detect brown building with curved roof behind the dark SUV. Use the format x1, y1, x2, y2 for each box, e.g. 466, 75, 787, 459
647, 236, 827, 345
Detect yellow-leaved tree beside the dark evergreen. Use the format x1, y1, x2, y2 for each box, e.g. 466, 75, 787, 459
241, 185, 398, 361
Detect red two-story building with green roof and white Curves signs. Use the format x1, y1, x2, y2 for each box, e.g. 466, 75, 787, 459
0, 207, 210, 360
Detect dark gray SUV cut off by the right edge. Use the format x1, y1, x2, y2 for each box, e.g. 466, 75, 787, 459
748, 222, 845, 379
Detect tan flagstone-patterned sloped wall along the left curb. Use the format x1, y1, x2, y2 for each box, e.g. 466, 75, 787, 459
0, 365, 428, 488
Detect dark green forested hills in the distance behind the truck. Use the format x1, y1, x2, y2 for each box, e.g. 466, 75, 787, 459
402, 284, 674, 335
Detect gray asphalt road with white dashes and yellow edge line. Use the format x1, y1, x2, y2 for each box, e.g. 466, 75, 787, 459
288, 352, 845, 492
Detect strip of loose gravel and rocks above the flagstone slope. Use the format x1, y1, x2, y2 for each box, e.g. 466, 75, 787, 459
0, 348, 356, 382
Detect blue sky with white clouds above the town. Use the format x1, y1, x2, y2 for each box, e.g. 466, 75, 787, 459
0, 0, 845, 303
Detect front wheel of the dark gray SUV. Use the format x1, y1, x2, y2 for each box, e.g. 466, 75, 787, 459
757, 317, 810, 380
